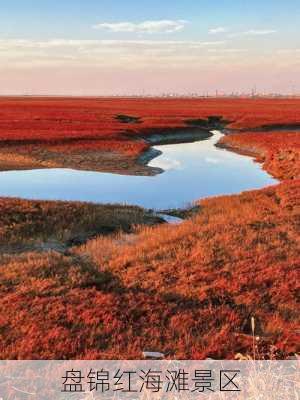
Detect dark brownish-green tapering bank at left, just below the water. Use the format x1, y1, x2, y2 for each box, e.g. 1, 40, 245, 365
0, 198, 165, 256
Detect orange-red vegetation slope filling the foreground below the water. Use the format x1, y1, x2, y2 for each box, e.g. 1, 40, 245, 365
0, 181, 300, 359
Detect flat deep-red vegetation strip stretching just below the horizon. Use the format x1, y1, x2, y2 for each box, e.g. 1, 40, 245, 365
0, 98, 300, 146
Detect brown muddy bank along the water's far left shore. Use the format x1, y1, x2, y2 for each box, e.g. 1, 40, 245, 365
0, 127, 212, 176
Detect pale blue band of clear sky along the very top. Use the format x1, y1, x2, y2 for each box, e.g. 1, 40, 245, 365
0, 0, 300, 38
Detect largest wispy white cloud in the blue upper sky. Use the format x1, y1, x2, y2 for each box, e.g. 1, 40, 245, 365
93, 19, 188, 34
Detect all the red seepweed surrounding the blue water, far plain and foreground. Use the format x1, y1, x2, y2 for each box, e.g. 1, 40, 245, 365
0, 98, 300, 359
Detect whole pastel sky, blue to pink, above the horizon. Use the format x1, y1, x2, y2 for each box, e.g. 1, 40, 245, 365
0, 0, 300, 95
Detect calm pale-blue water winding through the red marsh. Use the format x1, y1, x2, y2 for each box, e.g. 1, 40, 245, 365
0, 132, 277, 209
